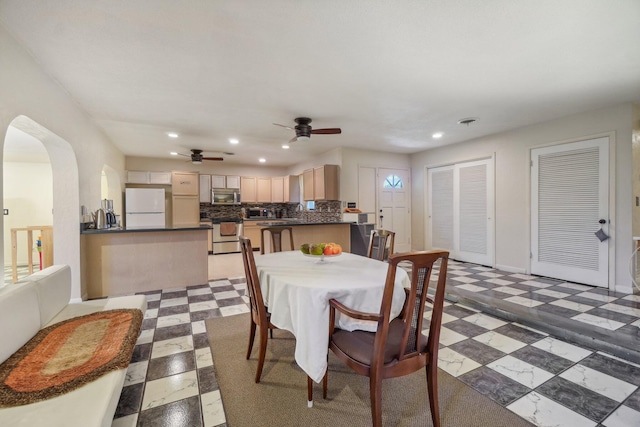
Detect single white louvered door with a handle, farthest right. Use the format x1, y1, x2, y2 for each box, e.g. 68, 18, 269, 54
531, 138, 609, 287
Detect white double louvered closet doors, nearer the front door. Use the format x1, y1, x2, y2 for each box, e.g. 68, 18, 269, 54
427, 159, 494, 266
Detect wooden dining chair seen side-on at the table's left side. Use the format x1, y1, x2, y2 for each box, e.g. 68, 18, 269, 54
239, 236, 278, 383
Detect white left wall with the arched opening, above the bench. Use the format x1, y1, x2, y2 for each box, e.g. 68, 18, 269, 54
0, 26, 124, 299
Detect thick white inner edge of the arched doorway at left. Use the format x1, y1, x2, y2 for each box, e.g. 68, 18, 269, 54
0, 116, 82, 300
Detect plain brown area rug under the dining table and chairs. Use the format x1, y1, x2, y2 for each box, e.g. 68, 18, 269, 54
205, 314, 532, 427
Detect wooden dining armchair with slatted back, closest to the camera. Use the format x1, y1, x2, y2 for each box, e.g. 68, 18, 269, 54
323, 251, 449, 427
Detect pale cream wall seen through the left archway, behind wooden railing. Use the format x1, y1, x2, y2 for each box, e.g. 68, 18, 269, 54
2, 162, 53, 266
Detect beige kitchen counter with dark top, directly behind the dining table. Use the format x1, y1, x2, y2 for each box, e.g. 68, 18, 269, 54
252, 219, 352, 253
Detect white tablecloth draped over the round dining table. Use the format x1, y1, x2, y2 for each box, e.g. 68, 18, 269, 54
255, 251, 410, 382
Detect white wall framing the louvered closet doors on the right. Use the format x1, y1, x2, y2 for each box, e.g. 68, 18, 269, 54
411, 104, 634, 292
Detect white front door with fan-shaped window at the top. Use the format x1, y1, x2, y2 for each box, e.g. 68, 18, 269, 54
376, 168, 411, 252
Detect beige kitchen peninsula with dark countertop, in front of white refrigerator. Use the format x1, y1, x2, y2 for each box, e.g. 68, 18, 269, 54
80, 226, 211, 299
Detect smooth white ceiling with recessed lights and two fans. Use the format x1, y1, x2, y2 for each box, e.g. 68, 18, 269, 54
0, 0, 640, 166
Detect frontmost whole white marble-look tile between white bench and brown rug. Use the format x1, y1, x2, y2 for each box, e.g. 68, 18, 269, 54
142, 371, 198, 413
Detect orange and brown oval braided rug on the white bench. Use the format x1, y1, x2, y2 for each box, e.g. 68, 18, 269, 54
0, 309, 142, 407
